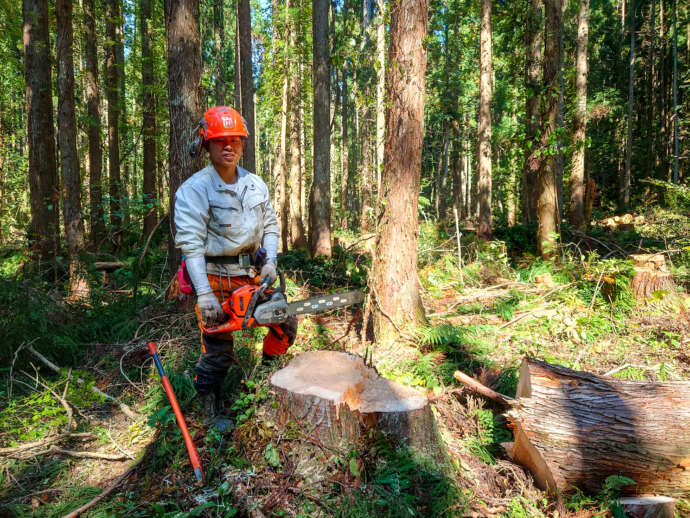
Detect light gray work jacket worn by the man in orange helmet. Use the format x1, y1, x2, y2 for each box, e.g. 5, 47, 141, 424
175, 164, 280, 276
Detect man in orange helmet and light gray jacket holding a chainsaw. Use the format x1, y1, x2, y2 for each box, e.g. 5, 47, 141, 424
175, 106, 297, 431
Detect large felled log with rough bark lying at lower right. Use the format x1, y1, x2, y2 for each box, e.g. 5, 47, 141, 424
507, 359, 690, 497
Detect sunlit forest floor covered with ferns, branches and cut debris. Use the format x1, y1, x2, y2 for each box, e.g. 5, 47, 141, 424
0, 205, 690, 518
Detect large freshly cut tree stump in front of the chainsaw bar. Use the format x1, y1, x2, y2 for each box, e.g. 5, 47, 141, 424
271, 351, 443, 459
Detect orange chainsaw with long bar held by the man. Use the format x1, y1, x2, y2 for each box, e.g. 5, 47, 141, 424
203, 272, 364, 334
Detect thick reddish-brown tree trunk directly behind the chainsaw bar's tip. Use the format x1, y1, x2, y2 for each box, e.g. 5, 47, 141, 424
370, 0, 429, 342
